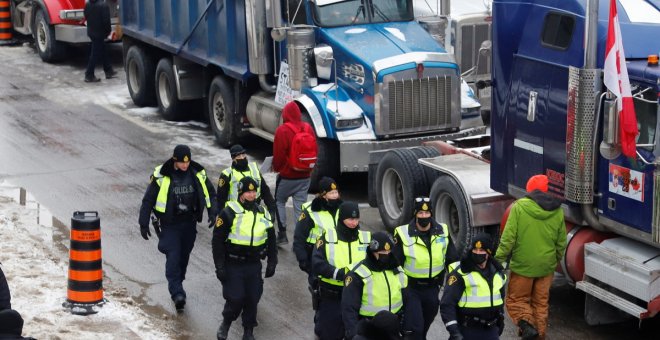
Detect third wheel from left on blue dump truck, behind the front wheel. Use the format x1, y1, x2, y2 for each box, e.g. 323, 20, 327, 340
208, 76, 239, 148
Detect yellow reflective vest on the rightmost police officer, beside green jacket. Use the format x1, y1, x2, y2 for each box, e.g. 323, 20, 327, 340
456, 267, 506, 308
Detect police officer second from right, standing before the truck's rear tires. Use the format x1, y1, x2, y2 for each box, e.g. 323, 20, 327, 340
394, 197, 459, 339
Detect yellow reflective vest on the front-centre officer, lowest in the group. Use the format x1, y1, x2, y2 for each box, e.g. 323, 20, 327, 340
354, 264, 408, 317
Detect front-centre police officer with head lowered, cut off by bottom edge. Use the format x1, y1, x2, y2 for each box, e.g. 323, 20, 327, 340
341, 231, 408, 339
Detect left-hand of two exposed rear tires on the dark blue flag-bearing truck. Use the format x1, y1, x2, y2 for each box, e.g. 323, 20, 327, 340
376, 149, 428, 231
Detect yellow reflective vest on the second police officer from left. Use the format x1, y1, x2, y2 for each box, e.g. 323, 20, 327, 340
227, 201, 273, 247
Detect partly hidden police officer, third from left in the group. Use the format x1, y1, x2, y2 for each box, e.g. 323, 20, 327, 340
293, 177, 342, 284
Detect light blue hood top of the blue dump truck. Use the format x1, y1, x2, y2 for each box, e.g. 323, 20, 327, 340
320, 21, 446, 71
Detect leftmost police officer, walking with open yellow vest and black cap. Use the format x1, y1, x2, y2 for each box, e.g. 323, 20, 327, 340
139, 145, 216, 311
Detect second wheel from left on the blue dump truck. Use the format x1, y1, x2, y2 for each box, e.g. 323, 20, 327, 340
154, 58, 184, 120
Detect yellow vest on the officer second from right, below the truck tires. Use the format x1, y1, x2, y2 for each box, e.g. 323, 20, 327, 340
396, 224, 449, 279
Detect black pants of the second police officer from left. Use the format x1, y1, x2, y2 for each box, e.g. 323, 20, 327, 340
222, 260, 264, 327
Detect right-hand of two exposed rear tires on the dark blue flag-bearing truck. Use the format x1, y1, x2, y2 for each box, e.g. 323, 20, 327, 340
430, 175, 474, 256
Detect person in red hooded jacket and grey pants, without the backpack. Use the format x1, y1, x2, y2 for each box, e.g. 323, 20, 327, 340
273, 102, 314, 244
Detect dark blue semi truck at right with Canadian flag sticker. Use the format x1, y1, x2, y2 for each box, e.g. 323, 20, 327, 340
371, 0, 660, 325
